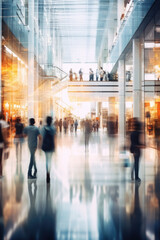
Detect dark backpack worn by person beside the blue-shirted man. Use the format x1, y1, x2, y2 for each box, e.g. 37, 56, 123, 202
42, 128, 55, 152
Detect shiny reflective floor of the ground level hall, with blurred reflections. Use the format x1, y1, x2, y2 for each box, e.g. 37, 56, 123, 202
0, 132, 160, 240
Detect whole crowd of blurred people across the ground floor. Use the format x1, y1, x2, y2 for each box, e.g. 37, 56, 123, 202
0, 111, 154, 183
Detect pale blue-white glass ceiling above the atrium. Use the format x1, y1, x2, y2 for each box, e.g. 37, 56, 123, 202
39, 0, 117, 63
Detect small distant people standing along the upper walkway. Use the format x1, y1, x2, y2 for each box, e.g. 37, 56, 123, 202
69, 67, 110, 81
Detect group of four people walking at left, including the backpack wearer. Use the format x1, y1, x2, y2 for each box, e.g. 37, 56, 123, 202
0, 115, 56, 183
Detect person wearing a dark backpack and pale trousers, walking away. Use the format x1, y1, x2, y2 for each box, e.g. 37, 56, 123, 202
42, 116, 56, 183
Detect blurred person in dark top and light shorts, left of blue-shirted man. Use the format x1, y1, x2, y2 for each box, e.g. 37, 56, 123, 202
14, 117, 24, 161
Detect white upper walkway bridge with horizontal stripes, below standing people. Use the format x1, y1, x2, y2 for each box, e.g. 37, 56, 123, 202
68, 81, 160, 101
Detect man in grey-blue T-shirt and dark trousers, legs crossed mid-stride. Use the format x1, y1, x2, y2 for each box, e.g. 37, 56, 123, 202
24, 118, 41, 179
